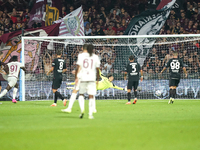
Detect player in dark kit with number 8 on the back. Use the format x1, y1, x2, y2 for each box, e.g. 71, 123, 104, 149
47, 50, 67, 106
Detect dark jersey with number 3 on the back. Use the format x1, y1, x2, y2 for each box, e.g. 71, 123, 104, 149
125, 62, 141, 81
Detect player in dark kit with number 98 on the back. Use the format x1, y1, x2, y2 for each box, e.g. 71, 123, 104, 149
161, 51, 187, 104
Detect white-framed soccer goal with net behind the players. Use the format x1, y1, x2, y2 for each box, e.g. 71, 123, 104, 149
19, 35, 200, 100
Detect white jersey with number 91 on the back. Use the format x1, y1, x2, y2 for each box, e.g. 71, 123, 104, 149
7, 61, 23, 78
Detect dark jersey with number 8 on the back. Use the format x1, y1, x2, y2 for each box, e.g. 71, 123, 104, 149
52, 58, 66, 77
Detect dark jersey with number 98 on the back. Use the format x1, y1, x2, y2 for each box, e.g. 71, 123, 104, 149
166, 58, 183, 79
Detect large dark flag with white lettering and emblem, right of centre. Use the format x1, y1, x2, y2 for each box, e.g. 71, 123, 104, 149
120, 0, 176, 66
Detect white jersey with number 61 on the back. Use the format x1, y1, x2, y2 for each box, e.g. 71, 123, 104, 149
77, 53, 100, 81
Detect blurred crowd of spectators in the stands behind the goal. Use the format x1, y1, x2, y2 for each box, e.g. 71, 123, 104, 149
0, 0, 200, 78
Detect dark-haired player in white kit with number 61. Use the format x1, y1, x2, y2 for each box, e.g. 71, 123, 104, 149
75, 44, 100, 119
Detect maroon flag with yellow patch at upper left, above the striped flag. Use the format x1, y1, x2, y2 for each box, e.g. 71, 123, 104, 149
28, 0, 62, 28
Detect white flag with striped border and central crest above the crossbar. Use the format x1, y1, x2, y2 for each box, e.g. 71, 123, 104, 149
55, 6, 84, 36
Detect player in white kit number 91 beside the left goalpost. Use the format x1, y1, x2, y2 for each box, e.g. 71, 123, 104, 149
0, 56, 26, 103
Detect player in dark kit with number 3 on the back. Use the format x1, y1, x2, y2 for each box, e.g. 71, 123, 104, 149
124, 55, 143, 104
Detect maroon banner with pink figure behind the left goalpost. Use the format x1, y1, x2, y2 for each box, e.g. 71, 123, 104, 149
0, 24, 60, 72
